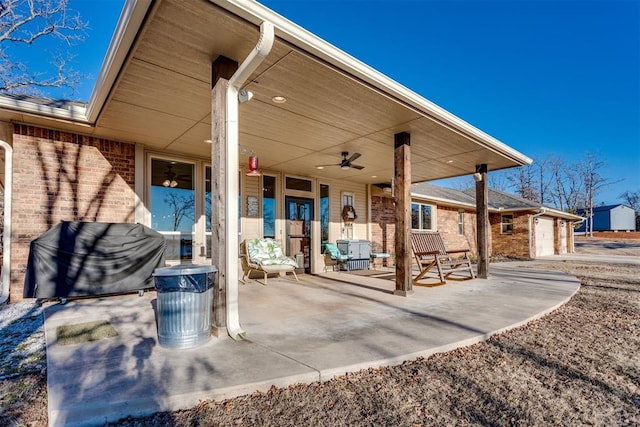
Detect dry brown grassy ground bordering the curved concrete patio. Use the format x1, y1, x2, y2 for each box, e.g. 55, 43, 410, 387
0, 240, 640, 426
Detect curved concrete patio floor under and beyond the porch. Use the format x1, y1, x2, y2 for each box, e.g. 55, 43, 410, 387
45, 263, 580, 426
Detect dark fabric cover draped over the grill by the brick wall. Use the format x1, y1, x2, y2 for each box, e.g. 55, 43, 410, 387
24, 221, 166, 298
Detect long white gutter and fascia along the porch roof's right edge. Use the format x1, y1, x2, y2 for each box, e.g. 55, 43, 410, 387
209, 0, 533, 165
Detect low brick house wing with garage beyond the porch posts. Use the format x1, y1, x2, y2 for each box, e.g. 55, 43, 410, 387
371, 183, 582, 263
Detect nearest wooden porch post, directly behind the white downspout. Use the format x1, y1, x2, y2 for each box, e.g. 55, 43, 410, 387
211, 56, 238, 337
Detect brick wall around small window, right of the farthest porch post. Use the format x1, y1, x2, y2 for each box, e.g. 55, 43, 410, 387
489, 212, 535, 259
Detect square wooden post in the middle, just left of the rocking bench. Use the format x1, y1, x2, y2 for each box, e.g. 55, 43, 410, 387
393, 132, 413, 296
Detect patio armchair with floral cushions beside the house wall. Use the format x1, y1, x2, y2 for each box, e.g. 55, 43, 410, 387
240, 238, 298, 285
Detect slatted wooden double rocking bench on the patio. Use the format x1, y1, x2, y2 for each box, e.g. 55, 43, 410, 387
411, 231, 476, 284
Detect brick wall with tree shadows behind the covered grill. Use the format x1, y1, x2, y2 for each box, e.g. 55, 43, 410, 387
10, 124, 135, 302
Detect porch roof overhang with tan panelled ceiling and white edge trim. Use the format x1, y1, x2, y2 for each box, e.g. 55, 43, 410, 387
0, 0, 531, 183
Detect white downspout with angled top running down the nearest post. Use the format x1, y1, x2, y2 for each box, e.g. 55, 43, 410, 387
225, 21, 275, 340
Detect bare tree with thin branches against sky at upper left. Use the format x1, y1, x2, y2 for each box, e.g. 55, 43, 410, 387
0, 0, 87, 95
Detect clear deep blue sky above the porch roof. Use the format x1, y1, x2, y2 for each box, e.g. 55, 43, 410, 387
12, 0, 640, 204
